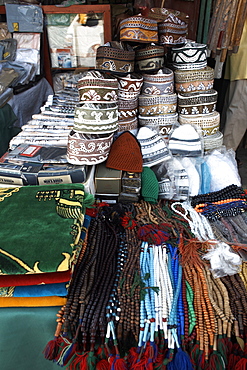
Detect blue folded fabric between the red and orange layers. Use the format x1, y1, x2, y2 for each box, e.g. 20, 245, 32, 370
0, 282, 69, 297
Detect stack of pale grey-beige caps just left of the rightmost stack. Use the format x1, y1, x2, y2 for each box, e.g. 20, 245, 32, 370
139, 67, 178, 140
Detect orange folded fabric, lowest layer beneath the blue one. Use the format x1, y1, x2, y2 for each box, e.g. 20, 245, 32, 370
0, 296, 67, 307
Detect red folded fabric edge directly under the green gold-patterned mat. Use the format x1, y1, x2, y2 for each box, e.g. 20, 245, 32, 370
0, 269, 72, 287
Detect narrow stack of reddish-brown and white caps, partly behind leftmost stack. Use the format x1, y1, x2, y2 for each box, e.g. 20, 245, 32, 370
117, 73, 143, 134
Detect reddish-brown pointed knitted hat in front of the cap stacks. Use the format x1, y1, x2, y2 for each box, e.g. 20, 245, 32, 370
106, 131, 142, 172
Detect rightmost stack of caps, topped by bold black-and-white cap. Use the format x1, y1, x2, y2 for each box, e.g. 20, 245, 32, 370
172, 41, 222, 150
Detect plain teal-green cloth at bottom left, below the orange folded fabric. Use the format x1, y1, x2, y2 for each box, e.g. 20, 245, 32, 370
0, 307, 60, 370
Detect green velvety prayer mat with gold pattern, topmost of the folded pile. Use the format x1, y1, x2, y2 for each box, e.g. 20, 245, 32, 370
0, 184, 94, 274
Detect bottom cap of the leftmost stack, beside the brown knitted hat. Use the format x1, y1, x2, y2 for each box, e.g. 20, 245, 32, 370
67, 131, 113, 165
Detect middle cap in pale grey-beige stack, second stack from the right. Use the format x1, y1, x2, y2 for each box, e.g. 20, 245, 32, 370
139, 94, 177, 116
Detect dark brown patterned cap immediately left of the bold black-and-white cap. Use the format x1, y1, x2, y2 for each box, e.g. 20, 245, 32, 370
135, 45, 165, 72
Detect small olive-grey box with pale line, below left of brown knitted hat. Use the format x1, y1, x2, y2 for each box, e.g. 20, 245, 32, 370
95, 162, 122, 194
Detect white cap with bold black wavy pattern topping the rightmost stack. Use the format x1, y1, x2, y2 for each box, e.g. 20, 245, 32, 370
172, 42, 207, 70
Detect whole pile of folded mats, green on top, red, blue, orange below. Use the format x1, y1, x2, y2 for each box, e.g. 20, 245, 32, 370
0, 184, 93, 307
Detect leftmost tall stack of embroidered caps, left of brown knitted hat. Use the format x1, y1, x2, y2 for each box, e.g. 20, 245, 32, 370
67, 70, 118, 165
